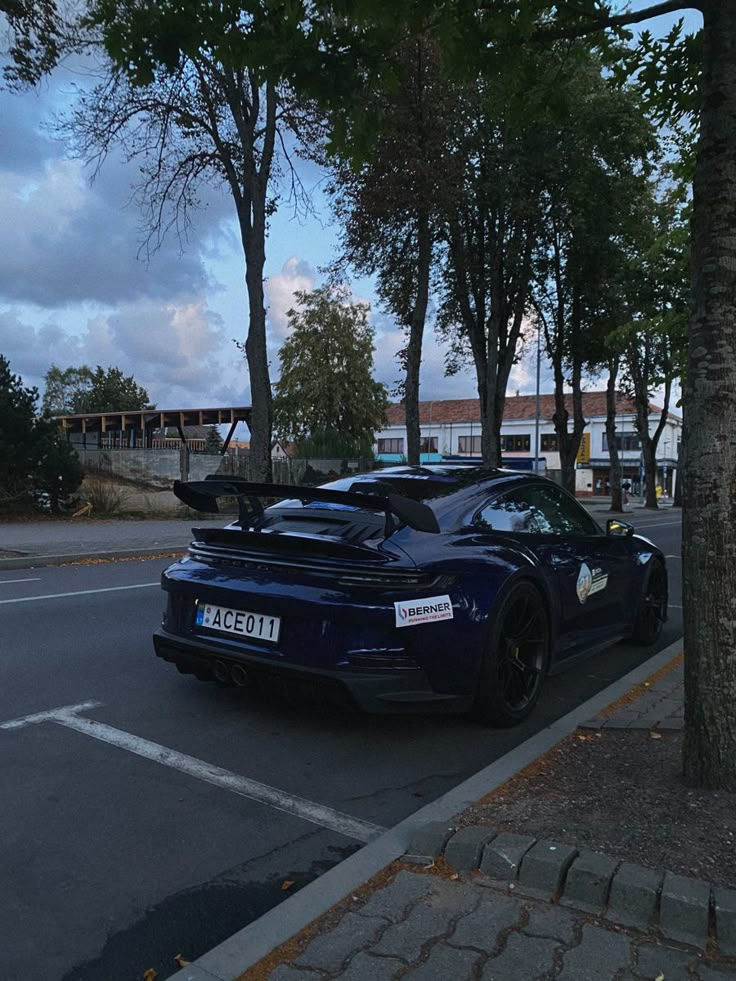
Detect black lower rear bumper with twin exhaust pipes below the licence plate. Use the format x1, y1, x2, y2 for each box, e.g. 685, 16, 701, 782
153, 629, 470, 713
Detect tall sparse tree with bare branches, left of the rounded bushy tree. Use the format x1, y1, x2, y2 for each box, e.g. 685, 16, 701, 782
67, 42, 322, 480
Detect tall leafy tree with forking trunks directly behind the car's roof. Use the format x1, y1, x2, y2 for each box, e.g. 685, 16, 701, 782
439, 66, 545, 466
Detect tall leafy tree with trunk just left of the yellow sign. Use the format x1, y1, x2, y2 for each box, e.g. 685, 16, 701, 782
533, 59, 656, 493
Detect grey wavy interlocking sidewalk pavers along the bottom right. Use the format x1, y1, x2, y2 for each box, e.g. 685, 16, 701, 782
270, 870, 736, 981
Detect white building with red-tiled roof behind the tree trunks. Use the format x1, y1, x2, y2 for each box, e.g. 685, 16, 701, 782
375, 392, 682, 496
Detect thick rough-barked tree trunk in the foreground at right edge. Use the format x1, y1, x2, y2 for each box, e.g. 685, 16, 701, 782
682, 0, 736, 789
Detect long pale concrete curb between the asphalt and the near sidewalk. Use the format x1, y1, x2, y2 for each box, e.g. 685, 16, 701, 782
169, 639, 682, 981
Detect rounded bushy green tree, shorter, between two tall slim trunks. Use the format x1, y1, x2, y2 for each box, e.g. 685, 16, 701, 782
274, 286, 388, 442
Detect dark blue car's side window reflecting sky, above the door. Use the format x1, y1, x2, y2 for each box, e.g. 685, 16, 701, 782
475, 485, 598, 535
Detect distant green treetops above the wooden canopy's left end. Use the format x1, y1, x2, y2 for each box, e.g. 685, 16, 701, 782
43, 365, 154, 415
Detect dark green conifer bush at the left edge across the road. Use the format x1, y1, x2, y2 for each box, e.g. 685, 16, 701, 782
0, 355, 83, 510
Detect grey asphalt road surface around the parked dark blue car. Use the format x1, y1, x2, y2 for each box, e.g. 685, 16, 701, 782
0, 512, 682, 981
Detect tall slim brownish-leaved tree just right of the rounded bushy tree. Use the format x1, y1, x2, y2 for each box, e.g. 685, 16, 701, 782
331, 34, 455, 464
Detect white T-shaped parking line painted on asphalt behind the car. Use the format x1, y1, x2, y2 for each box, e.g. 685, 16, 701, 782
0, 702, 386, 843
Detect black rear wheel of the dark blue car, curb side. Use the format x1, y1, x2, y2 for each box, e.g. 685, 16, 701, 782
474, 581, 550, 728
